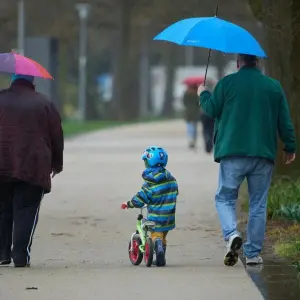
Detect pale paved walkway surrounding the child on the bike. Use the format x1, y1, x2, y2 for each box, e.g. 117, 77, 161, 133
0, 121, 262, 300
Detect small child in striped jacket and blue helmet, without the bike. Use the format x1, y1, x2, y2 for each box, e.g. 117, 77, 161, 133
122, 146, 178, 267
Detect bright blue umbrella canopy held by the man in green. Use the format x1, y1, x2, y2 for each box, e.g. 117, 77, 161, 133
154, 17, 267, 58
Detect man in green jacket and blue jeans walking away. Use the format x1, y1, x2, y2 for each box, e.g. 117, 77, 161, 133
198, 54, 296, 266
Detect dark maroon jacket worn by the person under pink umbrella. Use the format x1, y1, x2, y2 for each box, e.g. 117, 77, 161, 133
0, 79, 64, 193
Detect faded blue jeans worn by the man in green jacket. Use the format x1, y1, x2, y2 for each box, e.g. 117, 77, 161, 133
215, 157, 274, 258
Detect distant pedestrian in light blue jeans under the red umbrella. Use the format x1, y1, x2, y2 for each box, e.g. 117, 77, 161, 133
183, 85, 200, 149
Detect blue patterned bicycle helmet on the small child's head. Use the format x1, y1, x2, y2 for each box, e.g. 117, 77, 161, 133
142, 146, 168, 168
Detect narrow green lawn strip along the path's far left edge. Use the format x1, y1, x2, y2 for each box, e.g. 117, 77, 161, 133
63, 121, 125, 137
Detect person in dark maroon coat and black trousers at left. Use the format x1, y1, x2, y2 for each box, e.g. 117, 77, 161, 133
0, 75, 64, 267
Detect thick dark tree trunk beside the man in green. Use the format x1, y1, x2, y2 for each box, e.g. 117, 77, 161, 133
249, 0, 300, 175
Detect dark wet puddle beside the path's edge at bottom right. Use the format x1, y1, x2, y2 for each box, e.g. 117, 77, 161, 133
241, 258, 300, 300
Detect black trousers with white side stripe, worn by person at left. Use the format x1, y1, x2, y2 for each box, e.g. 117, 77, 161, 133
0, 181, 44, 265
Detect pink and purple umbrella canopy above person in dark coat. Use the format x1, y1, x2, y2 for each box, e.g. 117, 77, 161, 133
0, 52, 53, 79
